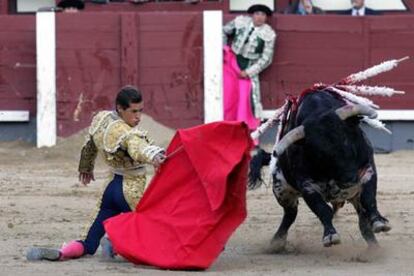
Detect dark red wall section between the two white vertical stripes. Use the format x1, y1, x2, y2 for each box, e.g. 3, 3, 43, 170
56, 12, 203, 136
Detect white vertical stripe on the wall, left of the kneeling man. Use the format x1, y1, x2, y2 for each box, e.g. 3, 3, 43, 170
36, 12, 56, 147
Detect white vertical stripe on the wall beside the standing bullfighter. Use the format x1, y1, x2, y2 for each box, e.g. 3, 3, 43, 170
203, 11, 223, 123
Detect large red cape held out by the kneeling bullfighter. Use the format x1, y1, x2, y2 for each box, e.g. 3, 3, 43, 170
104, 122, 252, 269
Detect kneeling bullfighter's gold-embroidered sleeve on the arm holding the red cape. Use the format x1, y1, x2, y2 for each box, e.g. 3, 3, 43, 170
124, 131, 164, 164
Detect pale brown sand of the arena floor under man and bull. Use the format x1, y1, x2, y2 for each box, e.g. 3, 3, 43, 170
0, 117, 414, 275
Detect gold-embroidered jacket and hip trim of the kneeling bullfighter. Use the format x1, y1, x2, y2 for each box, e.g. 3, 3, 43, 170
79, 111, 164, 210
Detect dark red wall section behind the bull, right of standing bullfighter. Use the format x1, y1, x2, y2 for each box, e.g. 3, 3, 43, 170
262, 15, 414, 109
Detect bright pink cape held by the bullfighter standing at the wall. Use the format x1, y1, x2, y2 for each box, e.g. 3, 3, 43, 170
223, 46, 260, 130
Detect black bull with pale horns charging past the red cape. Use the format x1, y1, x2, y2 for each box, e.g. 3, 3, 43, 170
249, 91, 391, 251
